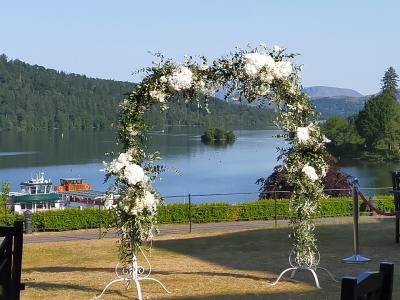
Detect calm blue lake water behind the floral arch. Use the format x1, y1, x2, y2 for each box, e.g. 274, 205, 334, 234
0, 128, 400, 202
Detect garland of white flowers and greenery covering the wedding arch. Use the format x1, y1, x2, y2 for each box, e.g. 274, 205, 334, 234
106, 45, 327, 269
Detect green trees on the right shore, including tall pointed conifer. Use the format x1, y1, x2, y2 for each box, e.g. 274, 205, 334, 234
322, 67, 400, 160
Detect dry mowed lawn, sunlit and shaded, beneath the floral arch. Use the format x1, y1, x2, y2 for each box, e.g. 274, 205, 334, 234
22, 219, 400, 299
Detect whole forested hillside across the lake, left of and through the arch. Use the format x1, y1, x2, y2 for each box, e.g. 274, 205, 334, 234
0, 55, 273, 130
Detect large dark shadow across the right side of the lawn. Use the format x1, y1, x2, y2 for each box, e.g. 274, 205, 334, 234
154, 219, 400, 299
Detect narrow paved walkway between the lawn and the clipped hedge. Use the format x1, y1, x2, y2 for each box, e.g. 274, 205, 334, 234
24, 217, 379, 243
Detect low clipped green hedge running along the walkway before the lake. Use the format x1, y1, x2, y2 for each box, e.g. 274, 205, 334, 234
2, 195, 394, 231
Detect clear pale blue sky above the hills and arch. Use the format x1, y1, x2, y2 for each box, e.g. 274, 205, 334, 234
0, 0, 400, 94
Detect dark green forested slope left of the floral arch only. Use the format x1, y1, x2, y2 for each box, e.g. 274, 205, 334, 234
0, 55, 133, 130
